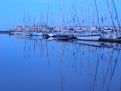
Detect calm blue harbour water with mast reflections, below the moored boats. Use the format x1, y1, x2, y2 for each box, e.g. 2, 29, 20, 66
0, 35, 121, 91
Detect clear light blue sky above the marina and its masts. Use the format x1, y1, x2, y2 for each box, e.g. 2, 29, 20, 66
0, 0, 121, 29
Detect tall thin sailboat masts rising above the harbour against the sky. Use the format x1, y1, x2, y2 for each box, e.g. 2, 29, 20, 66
13, 0, 121, 32
